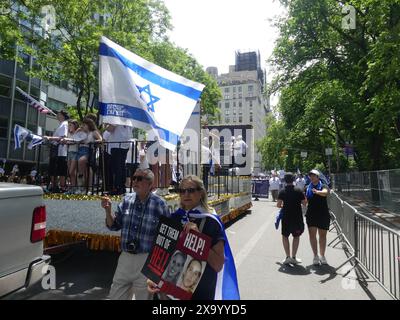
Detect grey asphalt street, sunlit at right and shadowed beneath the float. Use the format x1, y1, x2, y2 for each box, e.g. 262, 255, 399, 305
6, 199, 390, 300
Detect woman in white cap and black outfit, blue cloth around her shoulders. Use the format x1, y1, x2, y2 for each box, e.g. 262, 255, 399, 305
306, 170, 330, 265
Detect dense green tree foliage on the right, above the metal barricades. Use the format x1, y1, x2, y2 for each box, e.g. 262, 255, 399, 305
263, 0, 400, 171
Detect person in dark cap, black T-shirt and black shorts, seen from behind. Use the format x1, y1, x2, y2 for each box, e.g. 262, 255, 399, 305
277, 173, 307, 264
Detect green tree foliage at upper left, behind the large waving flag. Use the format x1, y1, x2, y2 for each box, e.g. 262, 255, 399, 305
0, 0, 219, 119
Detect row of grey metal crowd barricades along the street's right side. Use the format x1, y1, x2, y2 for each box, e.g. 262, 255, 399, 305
328, 193, 400, 300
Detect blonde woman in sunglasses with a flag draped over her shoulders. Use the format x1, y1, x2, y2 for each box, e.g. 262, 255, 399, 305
147, 176, 240, 300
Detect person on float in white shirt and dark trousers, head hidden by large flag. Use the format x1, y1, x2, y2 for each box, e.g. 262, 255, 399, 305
106, 124, 132, 195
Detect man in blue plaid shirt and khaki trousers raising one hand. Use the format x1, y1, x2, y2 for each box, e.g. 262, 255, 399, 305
101, 169, 170, 300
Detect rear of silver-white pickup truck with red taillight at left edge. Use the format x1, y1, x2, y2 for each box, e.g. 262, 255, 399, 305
0, 183, 50, 297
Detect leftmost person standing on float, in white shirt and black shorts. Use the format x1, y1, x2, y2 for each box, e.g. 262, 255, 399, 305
44, 110, 69, 192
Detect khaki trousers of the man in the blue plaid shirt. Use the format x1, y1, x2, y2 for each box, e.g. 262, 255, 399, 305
108, 252, 151, 300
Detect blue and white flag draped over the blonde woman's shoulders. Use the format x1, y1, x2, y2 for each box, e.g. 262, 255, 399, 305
172, 207, 240, 300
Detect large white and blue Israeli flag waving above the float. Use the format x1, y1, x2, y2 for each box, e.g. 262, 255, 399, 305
99, 37, 204, 150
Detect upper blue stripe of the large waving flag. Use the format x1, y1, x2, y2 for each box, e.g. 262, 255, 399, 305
99, 42, 201, 101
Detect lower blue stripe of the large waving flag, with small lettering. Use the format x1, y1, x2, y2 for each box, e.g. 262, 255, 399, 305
99, 102, 179, 145
